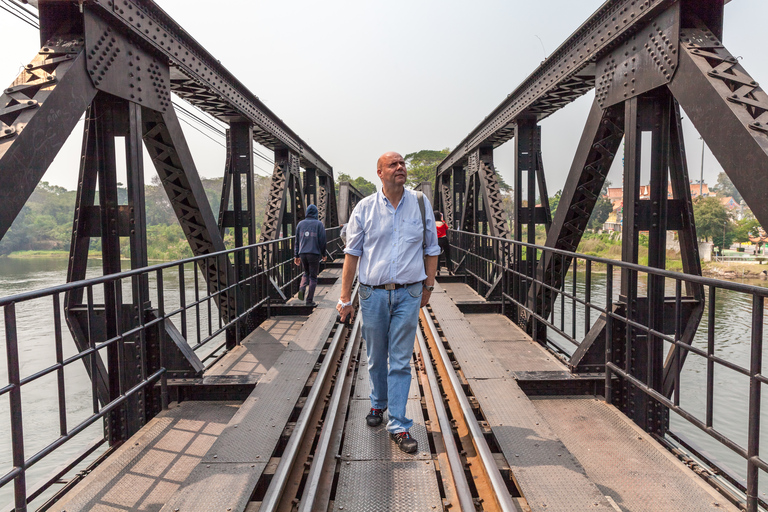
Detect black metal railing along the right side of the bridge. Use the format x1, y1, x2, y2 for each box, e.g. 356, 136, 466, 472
449, 231, 768, 511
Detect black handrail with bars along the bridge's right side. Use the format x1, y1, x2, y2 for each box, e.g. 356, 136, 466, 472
450, 230, 768, 512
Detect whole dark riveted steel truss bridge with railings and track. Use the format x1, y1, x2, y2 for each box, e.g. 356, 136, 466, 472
0, 0, 768, 511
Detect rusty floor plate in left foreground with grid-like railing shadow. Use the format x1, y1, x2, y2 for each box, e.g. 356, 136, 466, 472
51, 402, 239, 512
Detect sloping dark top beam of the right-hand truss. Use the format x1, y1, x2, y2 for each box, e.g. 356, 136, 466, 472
437, 0, 674, 176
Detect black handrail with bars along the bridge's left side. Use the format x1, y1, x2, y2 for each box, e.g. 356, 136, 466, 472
0, 227, 340, 510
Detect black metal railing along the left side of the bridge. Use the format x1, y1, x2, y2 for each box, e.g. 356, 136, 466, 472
0, 227, 343, 511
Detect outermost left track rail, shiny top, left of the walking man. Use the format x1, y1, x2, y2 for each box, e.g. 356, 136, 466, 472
259, 284, 360, 512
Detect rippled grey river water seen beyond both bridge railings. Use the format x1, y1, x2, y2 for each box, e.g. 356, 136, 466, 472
0, 258, 768, 510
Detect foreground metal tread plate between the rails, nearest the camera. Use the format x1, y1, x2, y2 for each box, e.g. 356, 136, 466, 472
333, 460, 443, 512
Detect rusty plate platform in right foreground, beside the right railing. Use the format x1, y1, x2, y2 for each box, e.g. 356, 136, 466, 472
532, 397, 738, 512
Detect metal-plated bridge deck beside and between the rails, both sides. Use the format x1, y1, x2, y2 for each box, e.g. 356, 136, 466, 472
53, 269, 737, 512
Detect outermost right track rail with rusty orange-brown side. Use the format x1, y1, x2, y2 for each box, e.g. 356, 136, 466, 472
422, 307, 517, 512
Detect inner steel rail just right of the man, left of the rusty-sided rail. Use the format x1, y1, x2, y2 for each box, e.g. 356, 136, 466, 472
416, 326, 476, 512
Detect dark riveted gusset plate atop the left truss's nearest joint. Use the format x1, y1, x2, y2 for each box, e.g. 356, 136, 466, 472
83, 9, 171, 112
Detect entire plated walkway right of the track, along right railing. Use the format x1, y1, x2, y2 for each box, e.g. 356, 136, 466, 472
430, 283, 738, 512
